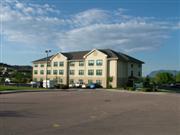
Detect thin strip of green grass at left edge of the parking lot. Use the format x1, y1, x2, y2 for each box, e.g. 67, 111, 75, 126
0, 85, 45, 91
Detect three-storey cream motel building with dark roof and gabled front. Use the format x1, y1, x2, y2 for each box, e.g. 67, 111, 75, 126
33, 49, 144, 88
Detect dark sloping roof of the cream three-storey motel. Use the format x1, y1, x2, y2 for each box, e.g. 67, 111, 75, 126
33, 49, 144, 63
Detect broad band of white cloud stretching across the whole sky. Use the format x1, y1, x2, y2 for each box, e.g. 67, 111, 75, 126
0, 0, 180, 52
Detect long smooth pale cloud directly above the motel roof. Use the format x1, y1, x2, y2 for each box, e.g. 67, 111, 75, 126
56, 21, 168, 52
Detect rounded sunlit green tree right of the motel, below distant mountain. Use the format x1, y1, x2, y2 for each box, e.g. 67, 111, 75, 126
155, 72, 175, 84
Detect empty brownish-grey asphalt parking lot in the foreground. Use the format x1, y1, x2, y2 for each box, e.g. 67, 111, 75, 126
0, 90, 180, 135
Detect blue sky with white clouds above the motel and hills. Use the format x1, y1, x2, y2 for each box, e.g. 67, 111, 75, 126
0, 0, 180, 75
